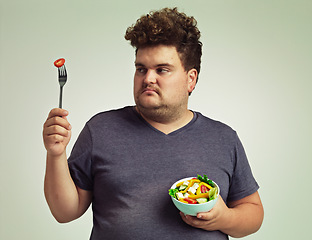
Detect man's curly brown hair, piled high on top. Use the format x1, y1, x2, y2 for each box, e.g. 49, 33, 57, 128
125, 8, 202, 81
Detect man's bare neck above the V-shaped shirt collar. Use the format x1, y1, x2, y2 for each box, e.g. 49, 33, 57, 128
136, 107, 194, 134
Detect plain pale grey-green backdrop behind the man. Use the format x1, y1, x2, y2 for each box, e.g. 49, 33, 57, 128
0, 0, 312, 240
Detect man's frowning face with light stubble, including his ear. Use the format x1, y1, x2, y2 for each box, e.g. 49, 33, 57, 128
134, 45, 197, 119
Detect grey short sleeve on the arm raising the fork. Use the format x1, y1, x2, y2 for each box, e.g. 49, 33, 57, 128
68, 125, 93, 191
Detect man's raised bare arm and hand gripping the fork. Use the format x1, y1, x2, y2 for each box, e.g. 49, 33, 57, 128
43, 108, 92, 223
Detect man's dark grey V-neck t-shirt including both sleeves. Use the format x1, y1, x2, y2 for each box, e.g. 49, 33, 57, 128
68, 107, 259, 240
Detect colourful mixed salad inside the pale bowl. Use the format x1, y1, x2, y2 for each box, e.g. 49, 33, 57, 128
169, 175, 218, 204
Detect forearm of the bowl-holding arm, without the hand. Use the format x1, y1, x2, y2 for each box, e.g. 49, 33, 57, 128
220, 203, 263, 238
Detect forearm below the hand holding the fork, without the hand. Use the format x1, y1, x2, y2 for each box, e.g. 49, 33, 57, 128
44, 153, 79, 222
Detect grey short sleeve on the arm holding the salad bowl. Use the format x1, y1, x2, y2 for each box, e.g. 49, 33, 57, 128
227, 134, 259, 201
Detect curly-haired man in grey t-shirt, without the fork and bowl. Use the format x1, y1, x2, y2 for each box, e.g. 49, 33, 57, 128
43, 8, 263, 240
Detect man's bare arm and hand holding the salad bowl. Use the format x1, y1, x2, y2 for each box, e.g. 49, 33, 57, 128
181, 192, 264, 238
